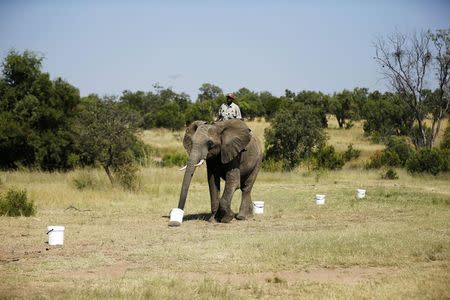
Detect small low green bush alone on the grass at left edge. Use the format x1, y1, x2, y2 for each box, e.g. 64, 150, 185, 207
0, 189, 36, 217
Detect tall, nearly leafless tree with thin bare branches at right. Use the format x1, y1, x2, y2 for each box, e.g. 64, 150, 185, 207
374, 29, 450, 147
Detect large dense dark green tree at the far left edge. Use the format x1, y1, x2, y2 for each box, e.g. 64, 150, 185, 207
0, 50, 80, 170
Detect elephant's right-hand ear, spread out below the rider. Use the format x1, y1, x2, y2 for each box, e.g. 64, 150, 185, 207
219, 119, 252, 164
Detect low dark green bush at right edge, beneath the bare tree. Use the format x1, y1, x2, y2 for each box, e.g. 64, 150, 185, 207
406, 148, 450, 175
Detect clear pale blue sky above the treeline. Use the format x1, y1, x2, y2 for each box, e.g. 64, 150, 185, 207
0, 0, 450, 100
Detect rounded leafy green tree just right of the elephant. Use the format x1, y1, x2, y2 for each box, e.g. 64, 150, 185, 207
264, 103, 325, 170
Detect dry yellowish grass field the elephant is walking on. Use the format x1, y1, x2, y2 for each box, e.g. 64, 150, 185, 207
0, 118, 450, 299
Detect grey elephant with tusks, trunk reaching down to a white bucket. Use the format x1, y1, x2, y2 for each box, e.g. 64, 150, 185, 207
178, 119, 262, 223
